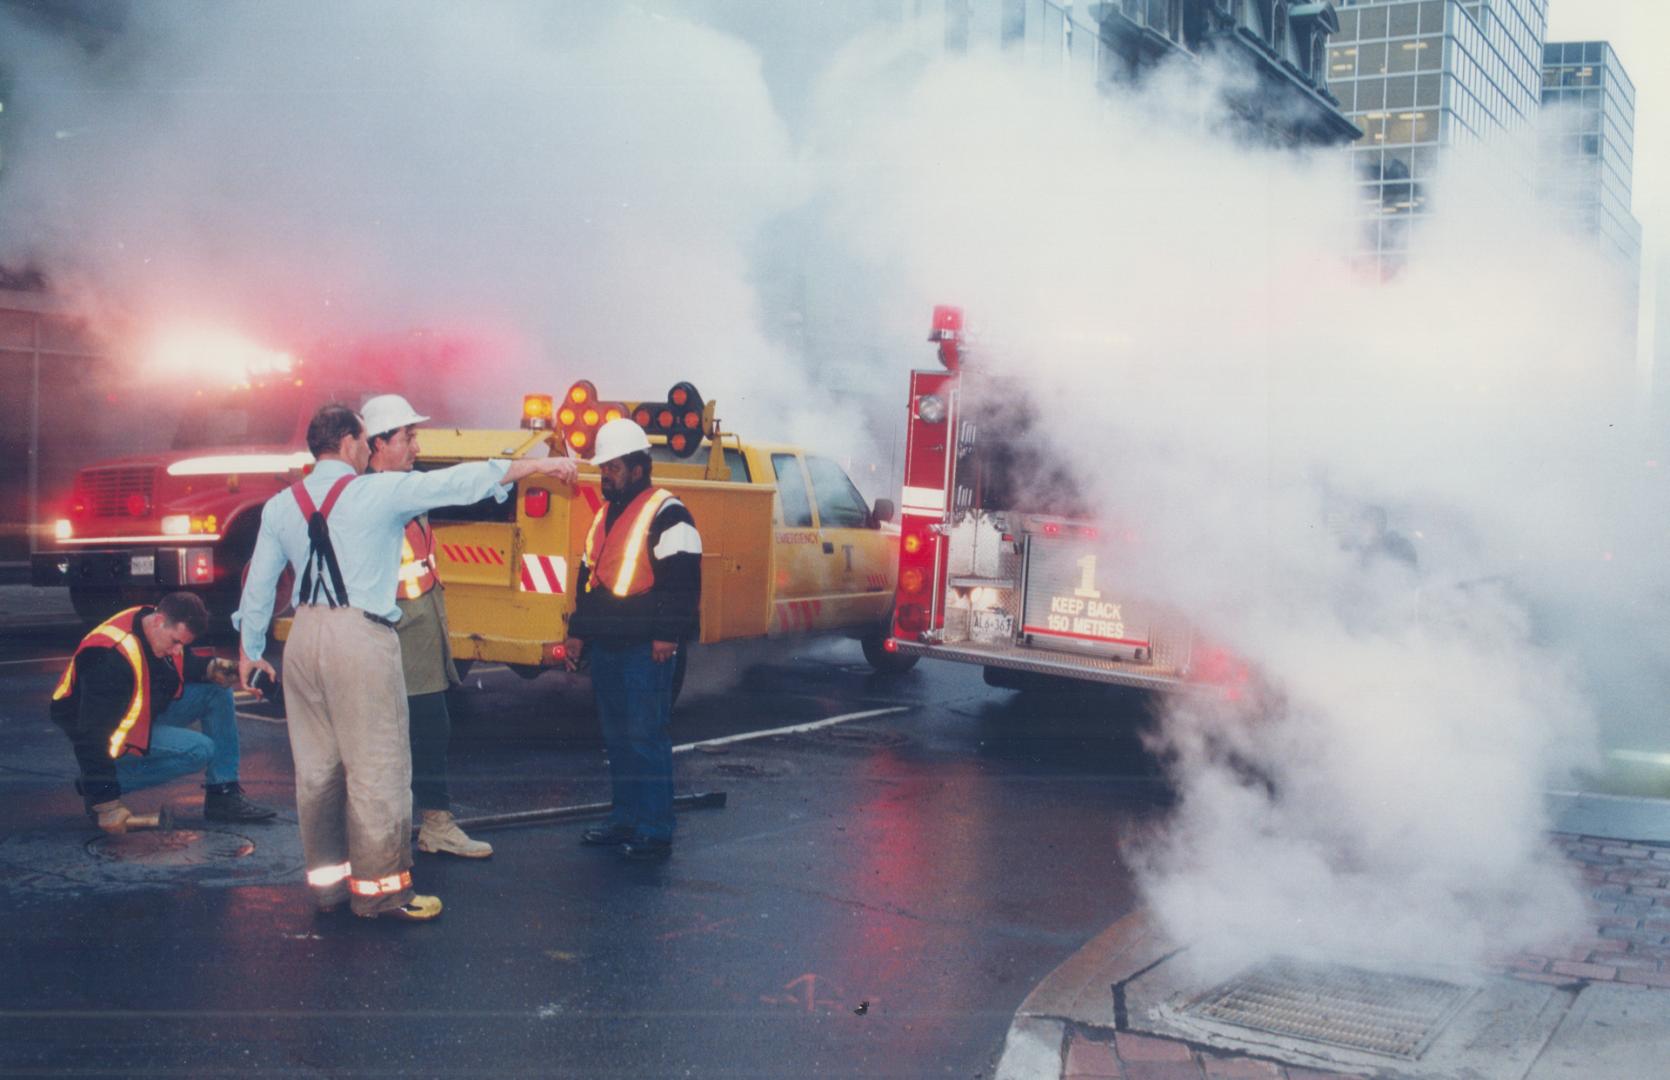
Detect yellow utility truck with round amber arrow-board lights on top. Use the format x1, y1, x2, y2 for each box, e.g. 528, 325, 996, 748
276, 381, 915, 678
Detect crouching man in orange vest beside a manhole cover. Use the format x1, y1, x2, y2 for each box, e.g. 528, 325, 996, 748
52, 593, 276, 835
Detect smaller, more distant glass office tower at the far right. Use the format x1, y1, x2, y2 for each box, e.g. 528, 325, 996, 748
1538, 42, 1642, 269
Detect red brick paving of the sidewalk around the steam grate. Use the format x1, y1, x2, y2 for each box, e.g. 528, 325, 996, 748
1062, 835, 1670, 1080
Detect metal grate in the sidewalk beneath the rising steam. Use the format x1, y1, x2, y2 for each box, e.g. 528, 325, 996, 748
1184, 960, 1473, 1060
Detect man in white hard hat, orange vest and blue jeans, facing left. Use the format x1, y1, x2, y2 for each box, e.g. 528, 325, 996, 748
566, 419, 701, 860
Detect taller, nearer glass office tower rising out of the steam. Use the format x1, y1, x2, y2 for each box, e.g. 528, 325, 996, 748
1328, 0, 1548, 270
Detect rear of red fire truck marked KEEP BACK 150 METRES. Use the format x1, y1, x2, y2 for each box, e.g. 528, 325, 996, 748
885, 305, 1246, 693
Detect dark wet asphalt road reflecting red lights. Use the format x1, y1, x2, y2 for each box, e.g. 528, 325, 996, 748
0, 631, 1167, 1077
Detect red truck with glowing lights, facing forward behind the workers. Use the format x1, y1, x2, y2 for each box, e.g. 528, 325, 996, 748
30, 354, 384, 623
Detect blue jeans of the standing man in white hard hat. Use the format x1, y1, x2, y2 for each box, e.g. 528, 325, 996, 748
586, 641, 675, 841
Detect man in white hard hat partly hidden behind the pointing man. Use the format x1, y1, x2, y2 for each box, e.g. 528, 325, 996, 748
361, 394, 493, 858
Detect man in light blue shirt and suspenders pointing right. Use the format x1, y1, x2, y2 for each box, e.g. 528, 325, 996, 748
234, 406, 576, 921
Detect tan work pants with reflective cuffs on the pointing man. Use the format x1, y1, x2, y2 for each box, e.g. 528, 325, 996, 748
284, 604, 412, 915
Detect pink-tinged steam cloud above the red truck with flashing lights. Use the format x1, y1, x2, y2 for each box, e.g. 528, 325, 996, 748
0, 2, 828, 431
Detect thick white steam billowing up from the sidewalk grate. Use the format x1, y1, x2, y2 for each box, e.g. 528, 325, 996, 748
820, 43, 1643, 968
